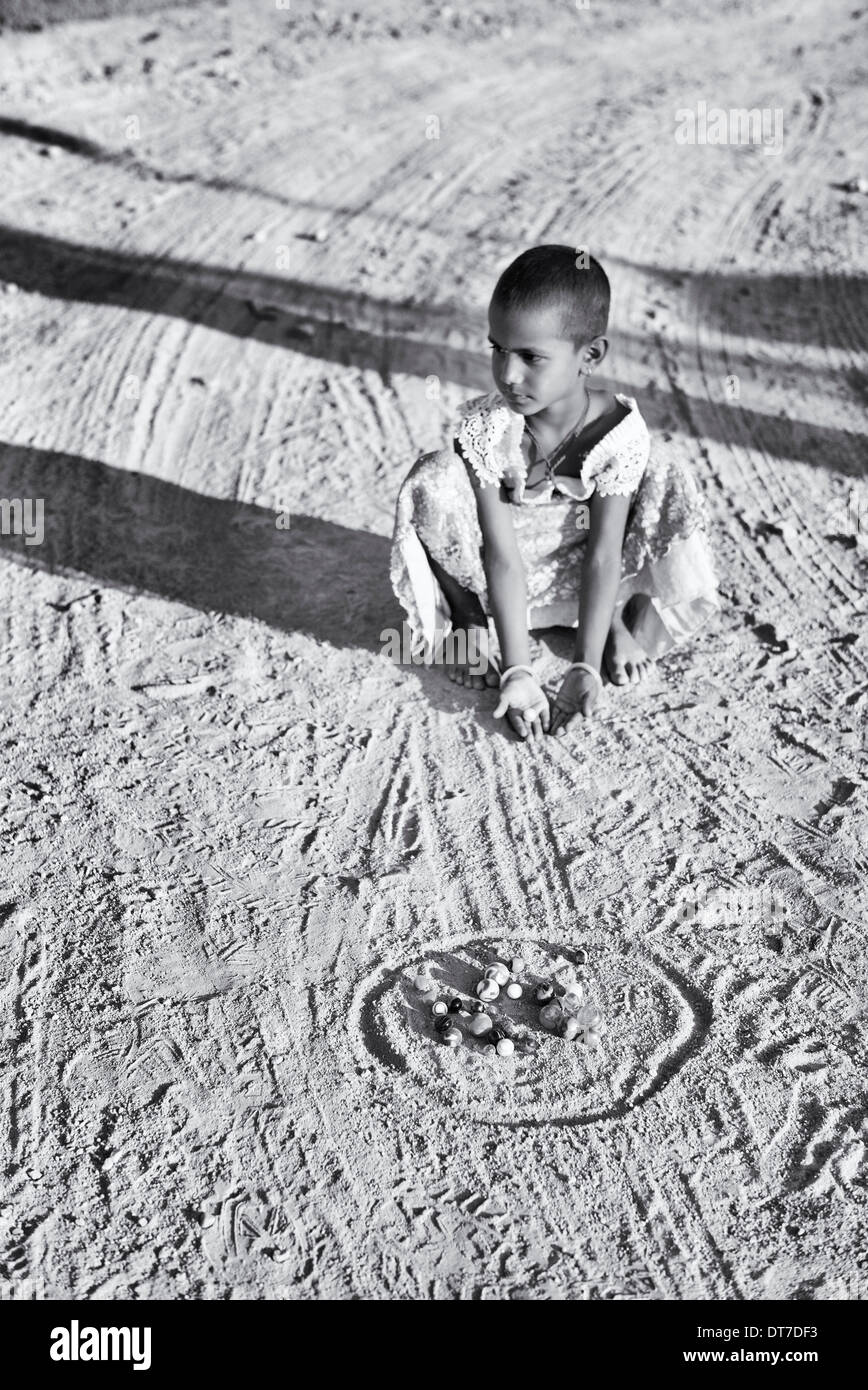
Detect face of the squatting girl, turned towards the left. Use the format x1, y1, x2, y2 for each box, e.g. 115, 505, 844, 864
488, 300, 588, 416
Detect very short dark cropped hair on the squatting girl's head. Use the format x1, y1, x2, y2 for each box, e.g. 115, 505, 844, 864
491, 246, 611, 346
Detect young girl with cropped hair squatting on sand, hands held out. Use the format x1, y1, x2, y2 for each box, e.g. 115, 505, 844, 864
391, 246, 719, 739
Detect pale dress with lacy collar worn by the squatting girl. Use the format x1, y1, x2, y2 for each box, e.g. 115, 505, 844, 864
389, 391, 719, 662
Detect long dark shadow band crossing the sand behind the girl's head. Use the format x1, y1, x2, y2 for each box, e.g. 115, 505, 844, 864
0, 227, 868, 475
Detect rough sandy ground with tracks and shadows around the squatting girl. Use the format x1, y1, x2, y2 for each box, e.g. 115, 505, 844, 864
0, 0, 868, 1300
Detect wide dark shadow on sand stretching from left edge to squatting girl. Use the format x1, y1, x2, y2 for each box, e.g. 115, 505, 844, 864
0, 443, 401, 652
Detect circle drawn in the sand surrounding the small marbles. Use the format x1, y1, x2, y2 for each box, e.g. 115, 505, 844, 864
353, 940, 711, 1127
